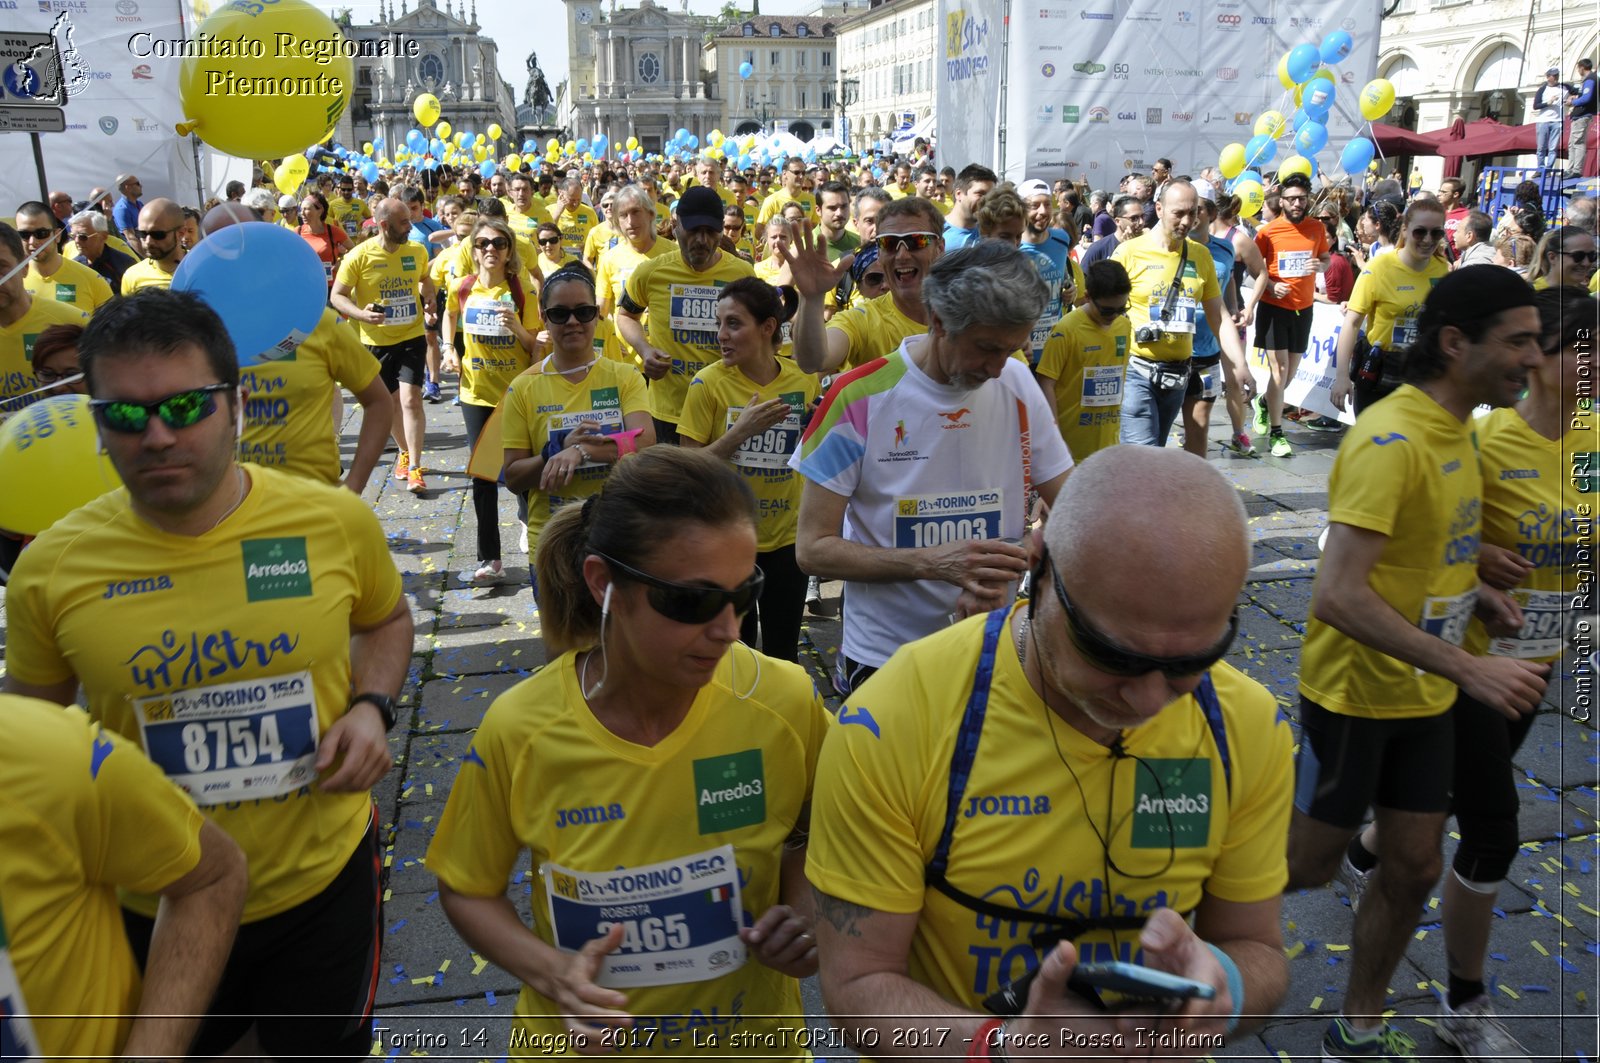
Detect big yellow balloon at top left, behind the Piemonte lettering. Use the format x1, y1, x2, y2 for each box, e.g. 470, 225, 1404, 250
178, 0, 355, 158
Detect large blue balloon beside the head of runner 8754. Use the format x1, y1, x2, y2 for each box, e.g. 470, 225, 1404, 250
173, 221, 328, 367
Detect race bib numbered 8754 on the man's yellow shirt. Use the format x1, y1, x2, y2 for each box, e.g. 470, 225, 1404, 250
133, 672, 318, 805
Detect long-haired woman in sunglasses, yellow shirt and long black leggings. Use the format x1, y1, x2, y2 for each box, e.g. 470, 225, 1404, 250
440, 218, 539, 586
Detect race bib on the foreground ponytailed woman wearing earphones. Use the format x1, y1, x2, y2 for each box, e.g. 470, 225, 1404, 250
539, 845, 746, 988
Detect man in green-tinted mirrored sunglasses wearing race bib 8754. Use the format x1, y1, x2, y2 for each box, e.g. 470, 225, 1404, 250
6, 290, 413, 1060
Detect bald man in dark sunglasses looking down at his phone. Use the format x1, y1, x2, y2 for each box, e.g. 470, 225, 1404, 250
806, 447, 1293, 1058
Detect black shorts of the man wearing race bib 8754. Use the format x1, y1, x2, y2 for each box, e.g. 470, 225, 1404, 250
122, 808, 382, 1060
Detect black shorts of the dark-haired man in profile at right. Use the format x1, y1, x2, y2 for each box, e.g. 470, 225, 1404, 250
1294, 695, 1456, 831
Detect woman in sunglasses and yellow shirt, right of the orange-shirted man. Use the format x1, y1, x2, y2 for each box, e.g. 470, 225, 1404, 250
1330, 200, 1450, 416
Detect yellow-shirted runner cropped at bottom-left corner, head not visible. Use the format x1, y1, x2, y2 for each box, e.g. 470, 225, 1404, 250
0, 695, 246, 1060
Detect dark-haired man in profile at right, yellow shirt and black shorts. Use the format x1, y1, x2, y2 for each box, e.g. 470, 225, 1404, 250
1290, 265, 1549, 1060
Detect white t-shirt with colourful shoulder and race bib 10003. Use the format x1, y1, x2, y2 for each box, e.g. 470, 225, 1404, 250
789, 344, 1072, 666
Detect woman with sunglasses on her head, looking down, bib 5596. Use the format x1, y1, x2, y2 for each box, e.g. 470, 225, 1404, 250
678, 277, 819, 661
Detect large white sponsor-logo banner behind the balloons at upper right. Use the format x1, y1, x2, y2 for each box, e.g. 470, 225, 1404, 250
1004, 0, 1381, 189
